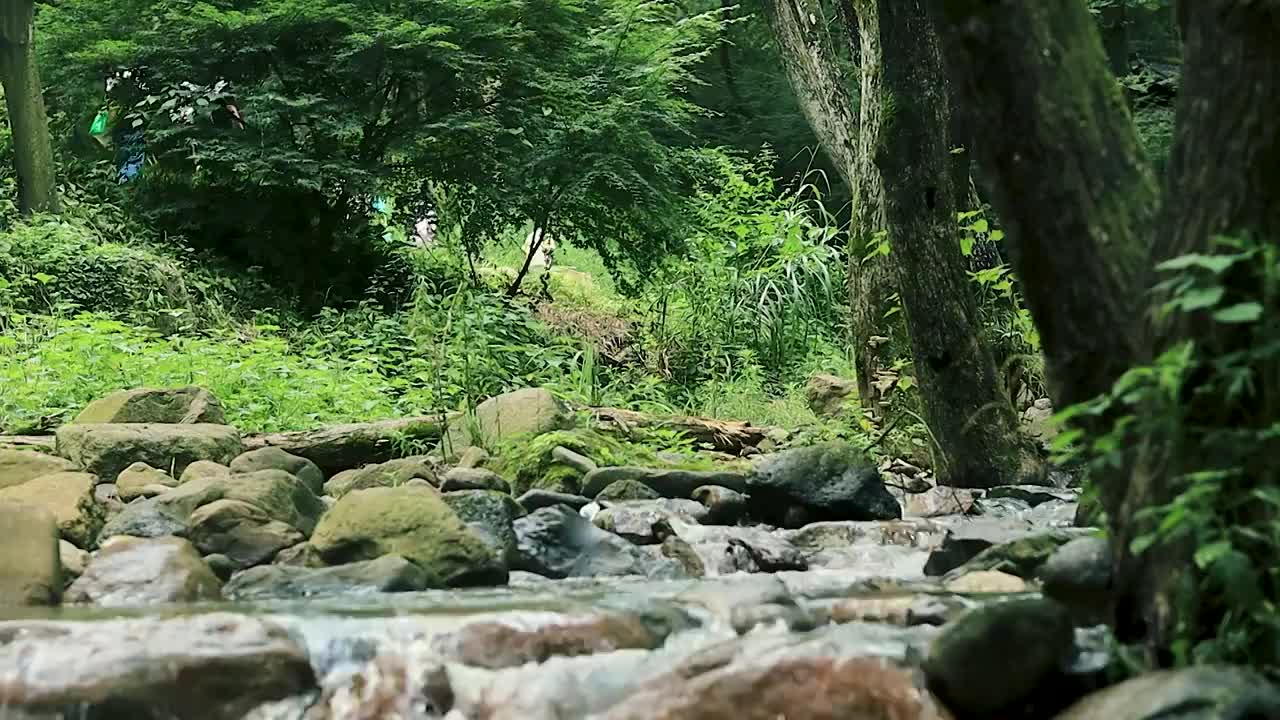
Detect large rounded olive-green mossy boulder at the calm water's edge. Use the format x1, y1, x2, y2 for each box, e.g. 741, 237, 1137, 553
311, 484, 507, 587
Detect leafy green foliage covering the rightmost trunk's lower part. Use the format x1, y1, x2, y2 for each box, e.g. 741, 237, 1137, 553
1060, 240, 1280, 667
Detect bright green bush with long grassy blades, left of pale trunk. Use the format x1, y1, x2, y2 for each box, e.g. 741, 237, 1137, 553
645, 147, 845, 384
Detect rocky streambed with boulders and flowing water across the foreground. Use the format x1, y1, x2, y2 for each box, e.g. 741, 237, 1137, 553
0, 388, 1280, 720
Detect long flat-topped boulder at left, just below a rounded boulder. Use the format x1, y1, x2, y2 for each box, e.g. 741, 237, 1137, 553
58, 423, 242, 483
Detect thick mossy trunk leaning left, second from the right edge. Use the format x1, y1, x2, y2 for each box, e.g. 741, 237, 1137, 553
931, 0, 1158, 407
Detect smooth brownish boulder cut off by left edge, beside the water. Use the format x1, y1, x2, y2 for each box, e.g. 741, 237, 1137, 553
0, 502, 63, 607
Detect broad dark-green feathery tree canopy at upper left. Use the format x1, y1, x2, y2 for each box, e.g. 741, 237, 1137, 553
40, 0, 719, 302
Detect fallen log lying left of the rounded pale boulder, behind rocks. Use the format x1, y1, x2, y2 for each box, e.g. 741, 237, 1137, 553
244, 413, 461, 475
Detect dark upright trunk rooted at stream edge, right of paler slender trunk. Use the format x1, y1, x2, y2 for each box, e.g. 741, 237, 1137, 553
876, 0, 1030, 487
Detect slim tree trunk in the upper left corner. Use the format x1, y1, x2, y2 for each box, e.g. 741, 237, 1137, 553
0, 0, 58, 215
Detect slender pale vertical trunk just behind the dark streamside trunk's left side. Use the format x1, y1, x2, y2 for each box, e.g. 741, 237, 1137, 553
845, 0, 909, 416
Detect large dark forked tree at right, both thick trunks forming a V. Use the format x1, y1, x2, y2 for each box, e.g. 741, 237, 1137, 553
932, 0, 1280, 656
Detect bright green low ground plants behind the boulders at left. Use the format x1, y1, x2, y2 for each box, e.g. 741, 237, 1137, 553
0, 314, 398, 432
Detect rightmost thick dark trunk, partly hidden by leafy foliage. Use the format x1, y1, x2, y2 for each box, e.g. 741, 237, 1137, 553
1108, 0, 1280, 661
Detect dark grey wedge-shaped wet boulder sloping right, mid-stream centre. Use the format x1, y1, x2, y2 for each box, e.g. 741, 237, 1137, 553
515, 505, 682, 578
